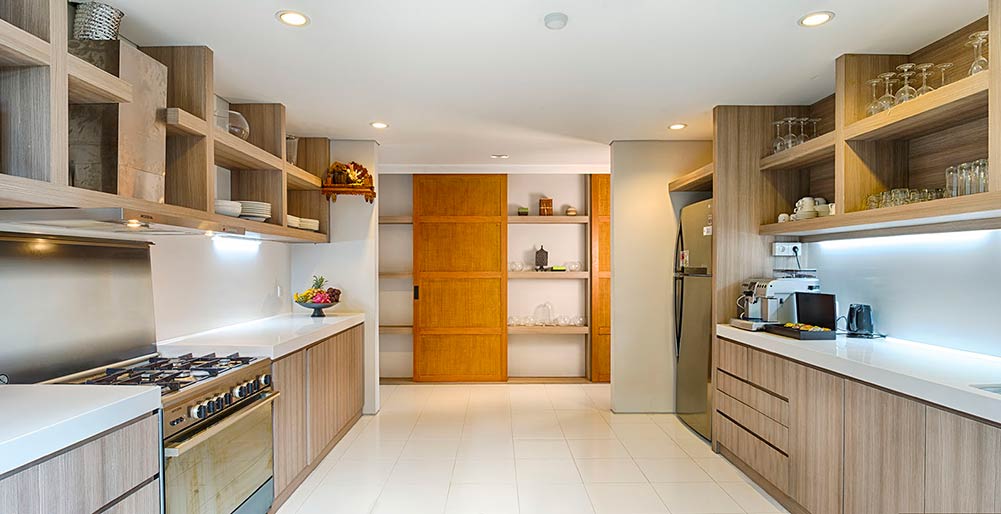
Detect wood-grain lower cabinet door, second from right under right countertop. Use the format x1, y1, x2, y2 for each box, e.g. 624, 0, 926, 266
845, 381, 920, 514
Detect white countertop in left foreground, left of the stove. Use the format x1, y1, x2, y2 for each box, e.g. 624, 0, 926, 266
0, 384, 160, 475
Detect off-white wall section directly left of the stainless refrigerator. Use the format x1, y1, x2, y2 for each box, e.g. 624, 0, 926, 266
612, 141, 713, 412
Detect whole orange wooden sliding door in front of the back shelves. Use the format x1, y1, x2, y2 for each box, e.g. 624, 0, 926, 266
413, 174, 508, 382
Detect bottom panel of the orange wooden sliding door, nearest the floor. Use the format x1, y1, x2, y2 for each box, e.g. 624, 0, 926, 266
413, 334, 508, 381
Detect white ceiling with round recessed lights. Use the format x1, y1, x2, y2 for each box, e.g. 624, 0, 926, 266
105, 0, 987, 169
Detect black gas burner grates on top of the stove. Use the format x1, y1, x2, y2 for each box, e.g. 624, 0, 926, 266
85, 354, 256, 394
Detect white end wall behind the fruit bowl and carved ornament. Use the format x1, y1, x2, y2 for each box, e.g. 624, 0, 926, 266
291, 141, 379, 414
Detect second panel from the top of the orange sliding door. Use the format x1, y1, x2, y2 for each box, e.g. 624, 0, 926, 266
414, 222, 507, 273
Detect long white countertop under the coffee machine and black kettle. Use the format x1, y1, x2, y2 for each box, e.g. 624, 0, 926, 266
716, 325, 1001, 424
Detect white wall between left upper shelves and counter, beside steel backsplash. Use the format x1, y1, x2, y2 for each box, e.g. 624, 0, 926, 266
150, 235, 291, 340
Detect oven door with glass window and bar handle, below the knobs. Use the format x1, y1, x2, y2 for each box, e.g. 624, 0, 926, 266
163, 388, 280, 514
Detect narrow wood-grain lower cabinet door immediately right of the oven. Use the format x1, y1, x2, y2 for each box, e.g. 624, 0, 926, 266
271, 352, 309, 495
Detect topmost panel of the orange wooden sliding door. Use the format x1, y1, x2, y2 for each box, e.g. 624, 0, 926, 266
413, 175, 508, 216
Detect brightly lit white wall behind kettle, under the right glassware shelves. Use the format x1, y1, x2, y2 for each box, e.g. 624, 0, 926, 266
806, 230, 1001, 356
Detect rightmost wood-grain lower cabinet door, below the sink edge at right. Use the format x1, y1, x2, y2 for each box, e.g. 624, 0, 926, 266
925, 407, 1001, 513
